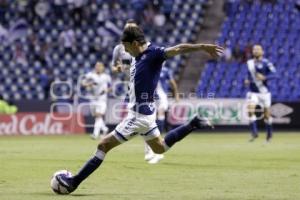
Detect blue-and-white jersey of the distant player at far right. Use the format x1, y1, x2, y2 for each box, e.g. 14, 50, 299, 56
247, 58, 276, 93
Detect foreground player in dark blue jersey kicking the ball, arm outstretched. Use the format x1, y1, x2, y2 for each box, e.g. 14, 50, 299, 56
56, 27, 223, 192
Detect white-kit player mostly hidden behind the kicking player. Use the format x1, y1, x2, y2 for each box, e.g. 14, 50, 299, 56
112, 19, 164, 164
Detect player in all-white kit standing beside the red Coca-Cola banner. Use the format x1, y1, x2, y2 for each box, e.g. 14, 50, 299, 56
81, 62, 111, 139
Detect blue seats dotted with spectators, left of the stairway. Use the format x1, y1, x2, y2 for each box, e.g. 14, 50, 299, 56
0, 0, 207, 100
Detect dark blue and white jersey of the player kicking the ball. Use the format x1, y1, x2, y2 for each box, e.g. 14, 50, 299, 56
128, 44, 166, 115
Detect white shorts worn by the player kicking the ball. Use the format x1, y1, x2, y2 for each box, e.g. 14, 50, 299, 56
113, 110, 160, 143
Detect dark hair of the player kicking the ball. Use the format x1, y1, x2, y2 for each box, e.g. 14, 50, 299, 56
121, 26, 146, 44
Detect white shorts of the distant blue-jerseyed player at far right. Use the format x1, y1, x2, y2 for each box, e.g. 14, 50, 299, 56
247, 92, 272, 108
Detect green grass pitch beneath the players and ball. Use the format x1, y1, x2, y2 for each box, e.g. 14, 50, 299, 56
0, 133, 300, 200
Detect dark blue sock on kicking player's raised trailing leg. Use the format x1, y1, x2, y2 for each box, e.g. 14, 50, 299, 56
164, 123, 194, 148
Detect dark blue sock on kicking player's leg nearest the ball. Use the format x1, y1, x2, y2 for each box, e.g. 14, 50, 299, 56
73, 150, 105, 187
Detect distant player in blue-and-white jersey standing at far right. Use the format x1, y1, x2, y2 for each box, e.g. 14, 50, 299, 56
245, 45, 276, 142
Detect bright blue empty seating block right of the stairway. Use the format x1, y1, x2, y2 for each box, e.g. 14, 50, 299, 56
197, 1, 300, 101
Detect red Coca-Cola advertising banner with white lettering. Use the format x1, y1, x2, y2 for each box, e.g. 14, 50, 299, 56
0, 113, 85, 135
